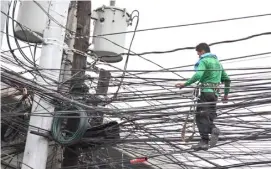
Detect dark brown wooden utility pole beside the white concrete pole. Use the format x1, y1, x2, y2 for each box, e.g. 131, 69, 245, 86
62, 0, 91, 167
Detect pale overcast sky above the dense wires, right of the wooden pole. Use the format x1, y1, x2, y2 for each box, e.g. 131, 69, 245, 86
92, 0, 271, 96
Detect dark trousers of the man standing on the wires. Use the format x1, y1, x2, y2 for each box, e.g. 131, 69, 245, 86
196, 92, 217, 141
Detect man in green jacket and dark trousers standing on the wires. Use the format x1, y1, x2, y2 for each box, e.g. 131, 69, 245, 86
175, 43, 230, 151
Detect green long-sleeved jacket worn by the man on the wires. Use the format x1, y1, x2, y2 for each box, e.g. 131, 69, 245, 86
185, 53, 230, 95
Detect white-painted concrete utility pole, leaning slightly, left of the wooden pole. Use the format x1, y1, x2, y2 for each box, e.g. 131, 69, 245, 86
22, 0, 70, 169
